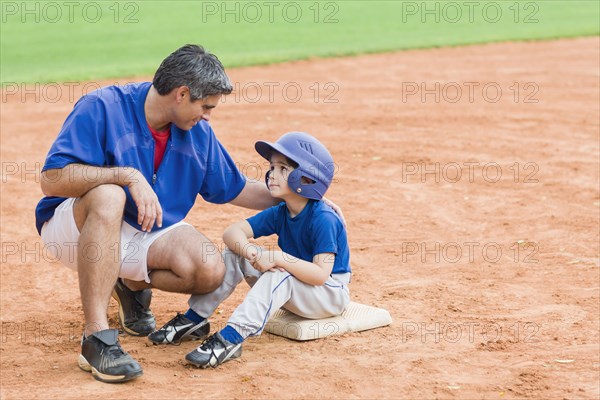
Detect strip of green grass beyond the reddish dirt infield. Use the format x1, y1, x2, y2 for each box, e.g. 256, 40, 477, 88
0, 0, 600, 84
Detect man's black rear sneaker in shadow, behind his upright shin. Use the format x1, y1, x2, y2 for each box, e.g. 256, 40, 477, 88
112, 279, 156, 336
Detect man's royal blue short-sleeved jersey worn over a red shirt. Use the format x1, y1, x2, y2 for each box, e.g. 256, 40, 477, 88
35, 82, 246, 232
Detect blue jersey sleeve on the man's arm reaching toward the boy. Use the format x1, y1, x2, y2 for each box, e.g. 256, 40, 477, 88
200, 128, 246, 204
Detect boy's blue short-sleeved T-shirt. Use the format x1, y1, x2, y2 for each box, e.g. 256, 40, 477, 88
247, 200, 351, 274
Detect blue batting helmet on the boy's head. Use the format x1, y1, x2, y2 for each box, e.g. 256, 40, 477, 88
254, 132, 335, 200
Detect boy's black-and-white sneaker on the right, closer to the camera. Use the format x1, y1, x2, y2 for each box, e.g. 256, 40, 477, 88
185, 332, 242, 368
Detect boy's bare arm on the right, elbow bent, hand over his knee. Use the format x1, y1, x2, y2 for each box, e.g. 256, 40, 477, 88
253, 250, 335, 286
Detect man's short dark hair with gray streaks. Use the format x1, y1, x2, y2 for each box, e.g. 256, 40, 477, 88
152, 44, 233, 101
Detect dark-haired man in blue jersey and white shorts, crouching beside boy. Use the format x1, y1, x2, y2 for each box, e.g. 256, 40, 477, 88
36, 45, 275, 382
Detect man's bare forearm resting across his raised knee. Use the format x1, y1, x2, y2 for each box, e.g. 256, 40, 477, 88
41, 164, 144, 197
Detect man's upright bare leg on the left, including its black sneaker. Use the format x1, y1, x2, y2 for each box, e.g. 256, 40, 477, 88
73, 185, 143, 383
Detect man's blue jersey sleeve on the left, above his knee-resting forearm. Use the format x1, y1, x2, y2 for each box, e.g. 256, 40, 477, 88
42, 94, 106, 172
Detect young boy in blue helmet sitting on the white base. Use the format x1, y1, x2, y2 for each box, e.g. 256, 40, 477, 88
149, 132, 351, 368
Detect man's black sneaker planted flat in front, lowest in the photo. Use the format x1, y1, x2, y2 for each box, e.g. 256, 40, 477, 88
78, 329, 143, 383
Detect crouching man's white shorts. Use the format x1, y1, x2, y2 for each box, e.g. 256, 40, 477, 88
42, 198, 189, 283
